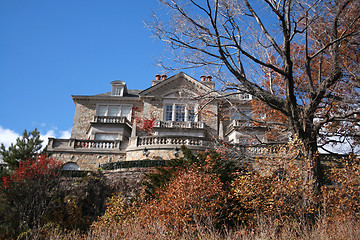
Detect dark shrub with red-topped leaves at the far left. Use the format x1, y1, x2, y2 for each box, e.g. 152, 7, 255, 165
0, 155, 60, 238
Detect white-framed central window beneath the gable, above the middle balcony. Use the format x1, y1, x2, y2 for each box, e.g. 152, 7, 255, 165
164, 103, 197, 122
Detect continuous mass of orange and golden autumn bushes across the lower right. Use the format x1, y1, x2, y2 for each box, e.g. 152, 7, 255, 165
88, 140, 360, 239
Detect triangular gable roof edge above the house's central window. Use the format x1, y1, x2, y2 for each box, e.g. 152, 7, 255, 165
139, 72, 213, 97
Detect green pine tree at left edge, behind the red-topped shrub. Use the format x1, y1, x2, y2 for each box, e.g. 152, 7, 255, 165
0, 128, 43, 169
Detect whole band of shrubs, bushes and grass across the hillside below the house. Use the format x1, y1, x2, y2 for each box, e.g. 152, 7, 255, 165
0, 140, 360, 239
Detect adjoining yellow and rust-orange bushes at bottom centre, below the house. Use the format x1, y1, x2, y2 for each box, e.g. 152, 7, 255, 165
91, 167, 225, 239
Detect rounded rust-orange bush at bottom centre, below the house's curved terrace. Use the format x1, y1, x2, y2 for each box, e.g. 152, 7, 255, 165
140, 168, 224, 229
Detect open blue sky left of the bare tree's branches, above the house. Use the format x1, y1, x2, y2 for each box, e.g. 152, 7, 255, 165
0, 0, 166, 145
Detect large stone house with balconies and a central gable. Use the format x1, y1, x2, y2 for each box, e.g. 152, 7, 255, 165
47, 72, 264, 170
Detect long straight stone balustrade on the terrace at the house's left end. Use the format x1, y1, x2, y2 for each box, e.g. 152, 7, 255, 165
47, 138, 121, 153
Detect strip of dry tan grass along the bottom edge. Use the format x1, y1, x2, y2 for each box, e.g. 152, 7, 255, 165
33, 219, 360, 240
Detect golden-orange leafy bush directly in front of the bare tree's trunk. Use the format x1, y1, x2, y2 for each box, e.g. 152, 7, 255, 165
229, 141, 315, 225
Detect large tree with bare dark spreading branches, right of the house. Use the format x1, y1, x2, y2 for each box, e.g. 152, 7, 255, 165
151, 0, 360, 189
